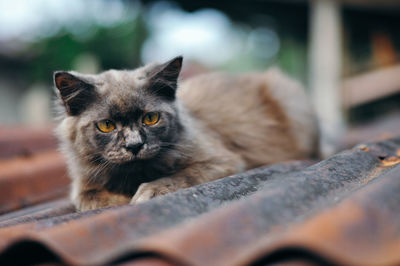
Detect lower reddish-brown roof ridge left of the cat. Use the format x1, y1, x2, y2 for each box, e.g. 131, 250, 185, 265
0, 151, 69, 214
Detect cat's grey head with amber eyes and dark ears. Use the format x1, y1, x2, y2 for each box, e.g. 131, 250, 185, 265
54, 56, 182, 164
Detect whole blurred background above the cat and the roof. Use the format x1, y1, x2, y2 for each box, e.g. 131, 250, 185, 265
0, 0, 400, 153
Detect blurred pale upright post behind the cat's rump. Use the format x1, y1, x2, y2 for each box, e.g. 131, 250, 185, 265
309, 0, 344, 156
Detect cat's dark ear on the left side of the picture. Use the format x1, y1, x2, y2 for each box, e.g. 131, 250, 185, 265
54, 71, 96, 116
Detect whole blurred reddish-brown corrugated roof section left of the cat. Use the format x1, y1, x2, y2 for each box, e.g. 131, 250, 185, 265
0, 128, 69, 214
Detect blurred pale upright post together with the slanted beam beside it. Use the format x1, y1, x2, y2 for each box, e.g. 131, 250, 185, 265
309, 0, 400, 155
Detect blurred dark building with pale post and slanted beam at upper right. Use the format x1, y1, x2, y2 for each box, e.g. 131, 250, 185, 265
144, 0, 400, 156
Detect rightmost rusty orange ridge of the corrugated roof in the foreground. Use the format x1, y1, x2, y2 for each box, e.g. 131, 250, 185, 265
252, 166, 400, 265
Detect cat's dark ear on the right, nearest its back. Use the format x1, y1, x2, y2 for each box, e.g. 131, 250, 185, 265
149, 56, 183, 100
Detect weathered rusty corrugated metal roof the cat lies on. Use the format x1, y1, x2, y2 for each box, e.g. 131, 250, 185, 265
0, 127, 400, 265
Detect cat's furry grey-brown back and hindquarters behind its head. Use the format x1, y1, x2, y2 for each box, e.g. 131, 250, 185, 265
178, 69, 318, 168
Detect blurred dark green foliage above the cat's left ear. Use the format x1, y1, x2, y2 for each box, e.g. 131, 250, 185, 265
25, 16, 148, 83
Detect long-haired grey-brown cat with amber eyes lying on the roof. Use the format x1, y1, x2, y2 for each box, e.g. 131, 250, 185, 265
54, 56, 318, 211
